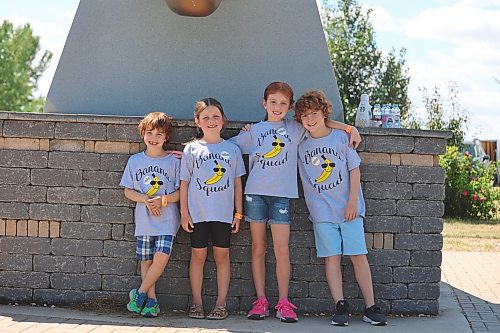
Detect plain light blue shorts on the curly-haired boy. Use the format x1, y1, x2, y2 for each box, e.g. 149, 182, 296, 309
313, 217, 368, 257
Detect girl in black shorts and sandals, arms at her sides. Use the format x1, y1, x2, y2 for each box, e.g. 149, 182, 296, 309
180, 98, 245, 319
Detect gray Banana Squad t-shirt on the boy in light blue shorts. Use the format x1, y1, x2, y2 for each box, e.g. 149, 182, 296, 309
299, 129, 365, 223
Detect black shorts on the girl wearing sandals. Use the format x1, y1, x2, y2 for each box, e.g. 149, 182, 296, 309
191, 221, 231, 249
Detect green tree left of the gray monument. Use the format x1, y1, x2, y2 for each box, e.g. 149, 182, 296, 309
0, 21, 52, 112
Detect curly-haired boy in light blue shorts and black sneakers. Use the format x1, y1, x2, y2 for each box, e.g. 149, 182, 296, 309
295, 91, 387, 326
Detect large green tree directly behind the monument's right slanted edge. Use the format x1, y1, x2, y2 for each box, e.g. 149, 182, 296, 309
322, 0, 410, 124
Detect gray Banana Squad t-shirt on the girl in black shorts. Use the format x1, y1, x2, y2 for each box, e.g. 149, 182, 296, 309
181, 140, 245, 223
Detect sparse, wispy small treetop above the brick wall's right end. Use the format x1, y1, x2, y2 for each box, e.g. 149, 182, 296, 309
404, 82, 469, 149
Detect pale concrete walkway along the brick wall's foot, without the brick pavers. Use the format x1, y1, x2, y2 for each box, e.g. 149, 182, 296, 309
0, 283, 471, 333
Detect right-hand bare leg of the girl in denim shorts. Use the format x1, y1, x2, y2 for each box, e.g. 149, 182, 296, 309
271, 224, 290, 299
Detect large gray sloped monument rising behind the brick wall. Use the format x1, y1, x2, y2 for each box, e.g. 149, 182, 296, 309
45, 0, 343, 121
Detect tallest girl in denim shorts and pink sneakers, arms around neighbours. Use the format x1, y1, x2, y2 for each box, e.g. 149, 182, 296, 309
231, 82, 361, 323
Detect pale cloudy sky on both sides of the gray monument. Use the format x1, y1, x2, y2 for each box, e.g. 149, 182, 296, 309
0, 0, 500, 139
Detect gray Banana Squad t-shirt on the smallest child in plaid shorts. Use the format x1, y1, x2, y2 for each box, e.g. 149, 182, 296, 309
120, 152, 181, 236
